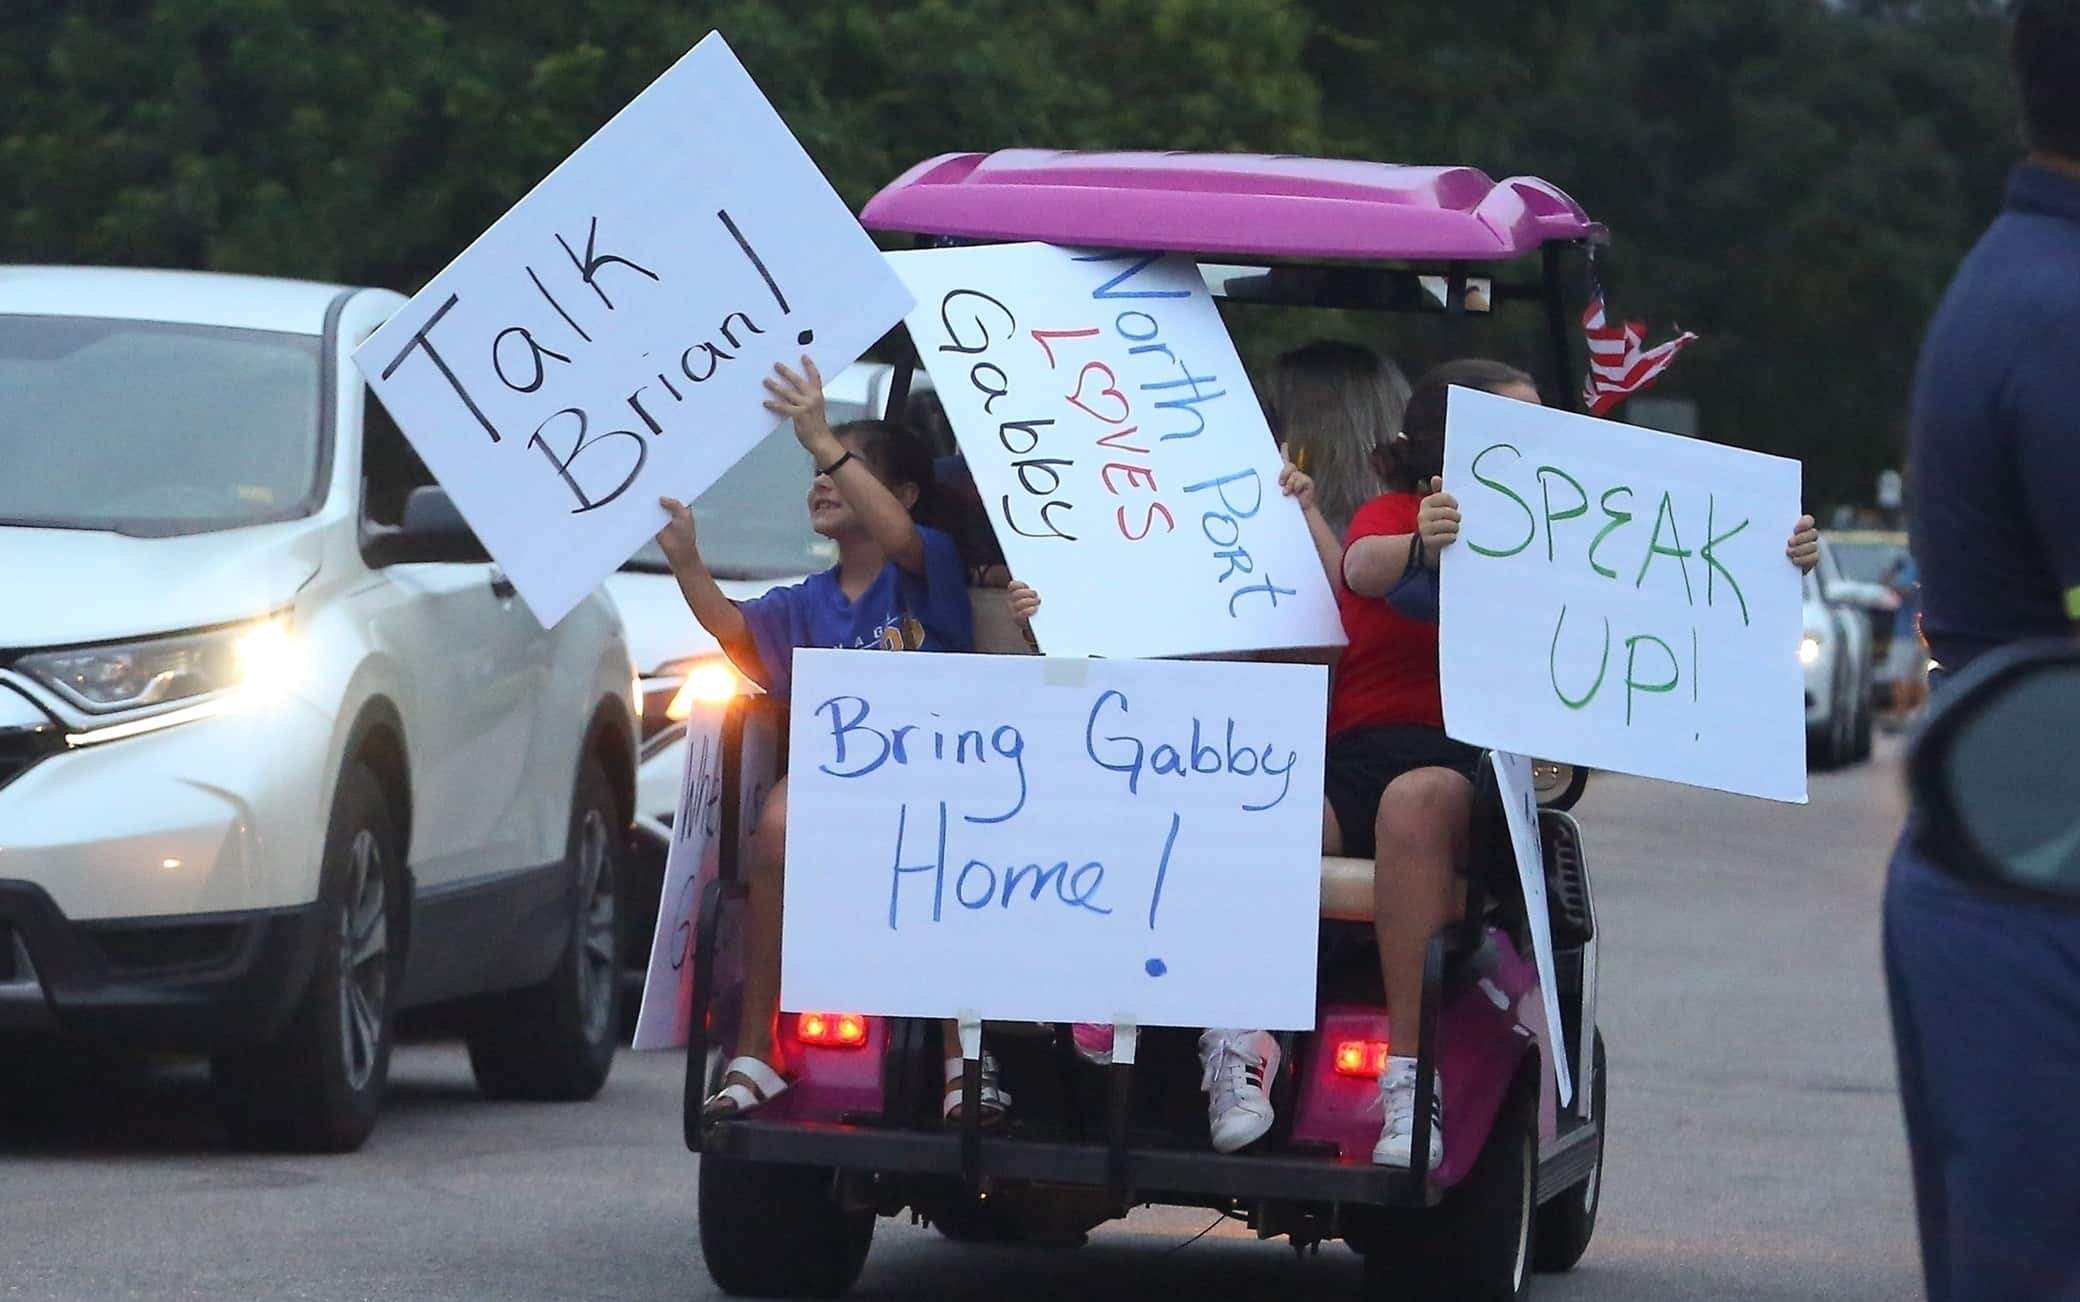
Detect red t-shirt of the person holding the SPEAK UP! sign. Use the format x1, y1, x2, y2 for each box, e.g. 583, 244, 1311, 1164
1329, 493, 1444, 736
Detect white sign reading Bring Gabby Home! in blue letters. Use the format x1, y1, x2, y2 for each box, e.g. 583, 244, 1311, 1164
780, 651, 1327, 1030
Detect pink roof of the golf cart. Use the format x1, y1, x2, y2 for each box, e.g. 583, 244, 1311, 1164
859, 150, 1604, 262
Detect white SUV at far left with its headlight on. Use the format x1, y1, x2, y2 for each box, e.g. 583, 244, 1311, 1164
0, 268, 639, 1150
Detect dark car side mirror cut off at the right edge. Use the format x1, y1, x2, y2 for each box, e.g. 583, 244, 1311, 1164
1907, 639, 2080, 907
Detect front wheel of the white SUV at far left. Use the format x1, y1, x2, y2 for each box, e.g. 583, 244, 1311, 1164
210, 761, 401, 1152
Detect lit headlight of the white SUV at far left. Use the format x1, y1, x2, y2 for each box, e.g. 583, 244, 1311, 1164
15, 616, 302, 715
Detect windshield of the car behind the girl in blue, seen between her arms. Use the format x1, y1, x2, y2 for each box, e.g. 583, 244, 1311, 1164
622, 399, 865, 578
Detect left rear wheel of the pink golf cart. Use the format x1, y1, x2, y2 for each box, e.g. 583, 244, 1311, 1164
699, 1152, 874, 1298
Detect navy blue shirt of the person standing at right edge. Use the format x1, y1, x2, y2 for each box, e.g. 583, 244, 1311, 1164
1907, 164, 2080, 670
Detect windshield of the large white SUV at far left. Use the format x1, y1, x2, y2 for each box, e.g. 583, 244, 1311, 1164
0, 316, 322, 537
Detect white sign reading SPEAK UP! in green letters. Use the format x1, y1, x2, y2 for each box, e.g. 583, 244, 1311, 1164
1437, 389, 1805, 803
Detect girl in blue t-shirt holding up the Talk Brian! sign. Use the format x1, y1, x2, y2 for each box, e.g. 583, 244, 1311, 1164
657, 358, 1040, 1121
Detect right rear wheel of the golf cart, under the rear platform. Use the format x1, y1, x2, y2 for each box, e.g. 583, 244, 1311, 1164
1364, 1059, 1539, 1302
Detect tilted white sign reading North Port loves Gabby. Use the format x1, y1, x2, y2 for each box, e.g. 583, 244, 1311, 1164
888, 243, 1344, 657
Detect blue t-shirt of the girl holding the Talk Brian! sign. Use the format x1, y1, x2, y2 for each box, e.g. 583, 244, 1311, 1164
738, 519, 976, 697
